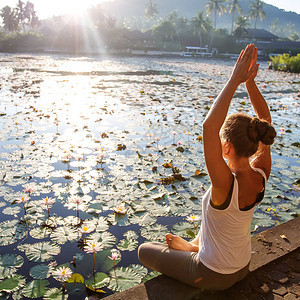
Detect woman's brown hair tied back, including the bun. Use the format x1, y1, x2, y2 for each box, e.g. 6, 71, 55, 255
221, 113, 276, 157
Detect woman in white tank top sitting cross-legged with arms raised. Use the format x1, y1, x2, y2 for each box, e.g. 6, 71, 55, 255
139, 44, 276, 290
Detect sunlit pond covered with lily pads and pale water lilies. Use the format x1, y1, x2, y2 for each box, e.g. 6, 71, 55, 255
0, 54, 300, 299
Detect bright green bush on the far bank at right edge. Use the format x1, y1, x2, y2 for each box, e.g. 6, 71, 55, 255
270, 53, 300, 73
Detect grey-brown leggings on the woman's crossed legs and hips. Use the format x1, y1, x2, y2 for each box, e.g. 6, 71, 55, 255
138, 242, 249, 290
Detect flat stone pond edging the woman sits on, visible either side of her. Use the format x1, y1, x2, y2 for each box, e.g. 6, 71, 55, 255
105, 217, 300, 300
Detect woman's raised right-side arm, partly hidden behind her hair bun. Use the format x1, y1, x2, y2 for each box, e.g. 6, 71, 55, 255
245, 48, 272, 178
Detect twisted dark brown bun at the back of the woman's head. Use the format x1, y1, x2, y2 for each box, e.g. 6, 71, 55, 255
248, 117, 276, 145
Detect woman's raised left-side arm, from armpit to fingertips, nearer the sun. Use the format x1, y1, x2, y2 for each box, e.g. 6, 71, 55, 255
202, 45, 254, 205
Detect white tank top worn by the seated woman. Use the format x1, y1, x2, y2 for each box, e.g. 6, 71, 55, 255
198, 168, 267, 274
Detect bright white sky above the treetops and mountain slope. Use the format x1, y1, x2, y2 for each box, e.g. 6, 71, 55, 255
0, 0, 300, 19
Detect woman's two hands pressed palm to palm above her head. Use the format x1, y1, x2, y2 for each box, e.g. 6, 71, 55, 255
230, 44, 258, 85
